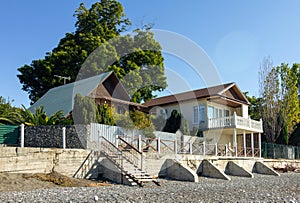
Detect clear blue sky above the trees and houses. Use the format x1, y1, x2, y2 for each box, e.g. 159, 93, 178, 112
0, 0, 300, 107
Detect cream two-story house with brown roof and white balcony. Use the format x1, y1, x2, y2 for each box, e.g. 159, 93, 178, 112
144, 83, 263, 156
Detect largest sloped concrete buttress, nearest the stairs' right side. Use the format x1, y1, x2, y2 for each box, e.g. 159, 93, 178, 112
159, 159, 198, 182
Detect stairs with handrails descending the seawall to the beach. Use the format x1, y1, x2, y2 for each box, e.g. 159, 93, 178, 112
100, 137, 160, 187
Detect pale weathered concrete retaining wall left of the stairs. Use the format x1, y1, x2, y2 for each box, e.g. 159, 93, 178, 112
0, 147, 90, 177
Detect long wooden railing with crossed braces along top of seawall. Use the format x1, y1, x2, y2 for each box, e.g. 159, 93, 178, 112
111, 136, 260, 159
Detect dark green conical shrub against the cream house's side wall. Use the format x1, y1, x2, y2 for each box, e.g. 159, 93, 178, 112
163, 110, 190, 135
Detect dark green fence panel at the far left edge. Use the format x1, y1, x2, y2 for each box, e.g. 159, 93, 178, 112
0, 125, 19, 145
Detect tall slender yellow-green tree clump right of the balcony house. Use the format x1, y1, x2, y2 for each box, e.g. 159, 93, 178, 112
260, 58, 300, 144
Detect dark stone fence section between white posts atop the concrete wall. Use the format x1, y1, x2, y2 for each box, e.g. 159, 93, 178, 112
24, 125, 90, 149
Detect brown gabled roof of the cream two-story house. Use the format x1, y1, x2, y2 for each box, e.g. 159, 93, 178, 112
144, 83, 250, 107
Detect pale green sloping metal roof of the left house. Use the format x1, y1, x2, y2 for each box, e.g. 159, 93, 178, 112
29, 71, 113, 116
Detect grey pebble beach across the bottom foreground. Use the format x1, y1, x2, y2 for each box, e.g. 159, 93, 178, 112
0, 173, 300, 202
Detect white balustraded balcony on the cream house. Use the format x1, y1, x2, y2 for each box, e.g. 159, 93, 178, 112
208, 113, 263, 133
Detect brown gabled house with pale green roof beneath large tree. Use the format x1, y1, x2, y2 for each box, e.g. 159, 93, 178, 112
29, 71, 145, 116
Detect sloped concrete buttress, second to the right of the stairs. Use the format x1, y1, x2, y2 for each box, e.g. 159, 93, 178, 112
197, 159, 231, 180
